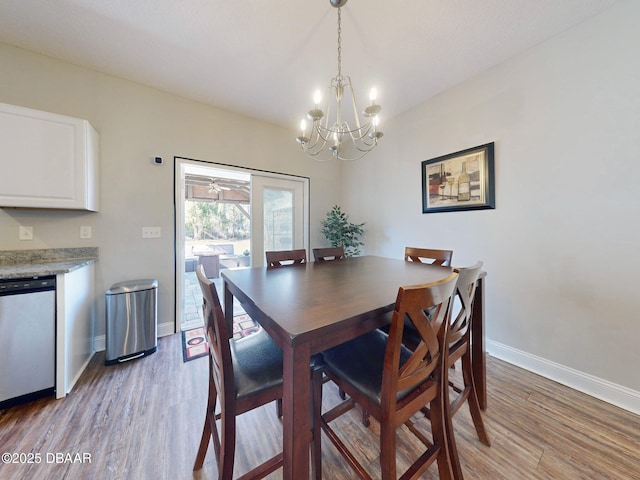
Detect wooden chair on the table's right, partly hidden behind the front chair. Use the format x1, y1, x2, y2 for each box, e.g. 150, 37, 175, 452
423, 262, 491, 478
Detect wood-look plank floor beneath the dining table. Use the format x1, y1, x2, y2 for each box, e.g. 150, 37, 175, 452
0, 335, 640, 480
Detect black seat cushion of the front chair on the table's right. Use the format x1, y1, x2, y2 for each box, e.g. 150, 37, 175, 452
322, 329, 412, 404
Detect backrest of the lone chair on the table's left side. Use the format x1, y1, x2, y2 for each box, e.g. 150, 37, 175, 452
196, 265, 235, 408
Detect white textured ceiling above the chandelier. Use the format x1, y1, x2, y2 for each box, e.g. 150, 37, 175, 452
0, 0, 616, 129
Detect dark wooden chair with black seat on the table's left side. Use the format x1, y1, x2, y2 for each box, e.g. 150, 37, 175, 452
193, 265, 320, 480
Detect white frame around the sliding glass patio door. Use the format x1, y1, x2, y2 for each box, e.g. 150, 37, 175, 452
173, 156, 310, 332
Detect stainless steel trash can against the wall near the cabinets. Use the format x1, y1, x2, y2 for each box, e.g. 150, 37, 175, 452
105, 280, 158, 365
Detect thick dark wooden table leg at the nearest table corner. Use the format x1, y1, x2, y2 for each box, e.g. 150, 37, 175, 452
282, 344, 311, 480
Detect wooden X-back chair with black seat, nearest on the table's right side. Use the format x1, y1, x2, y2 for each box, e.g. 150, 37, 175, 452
316, 273, 458, 480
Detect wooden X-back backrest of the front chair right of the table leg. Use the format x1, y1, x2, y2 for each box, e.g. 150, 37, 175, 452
381, 273, 458, 413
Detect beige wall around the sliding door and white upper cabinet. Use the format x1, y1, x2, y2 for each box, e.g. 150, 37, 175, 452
0, 44, 340, 336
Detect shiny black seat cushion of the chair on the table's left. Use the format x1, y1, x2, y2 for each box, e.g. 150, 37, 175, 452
229, 328, 282, 398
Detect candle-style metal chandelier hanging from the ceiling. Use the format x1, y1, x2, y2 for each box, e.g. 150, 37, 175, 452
296, 0, 382, 160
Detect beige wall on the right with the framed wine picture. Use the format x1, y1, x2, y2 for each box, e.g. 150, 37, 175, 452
343, 1, 640, 412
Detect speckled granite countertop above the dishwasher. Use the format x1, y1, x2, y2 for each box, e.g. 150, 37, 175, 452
0, 247, 98, 279
